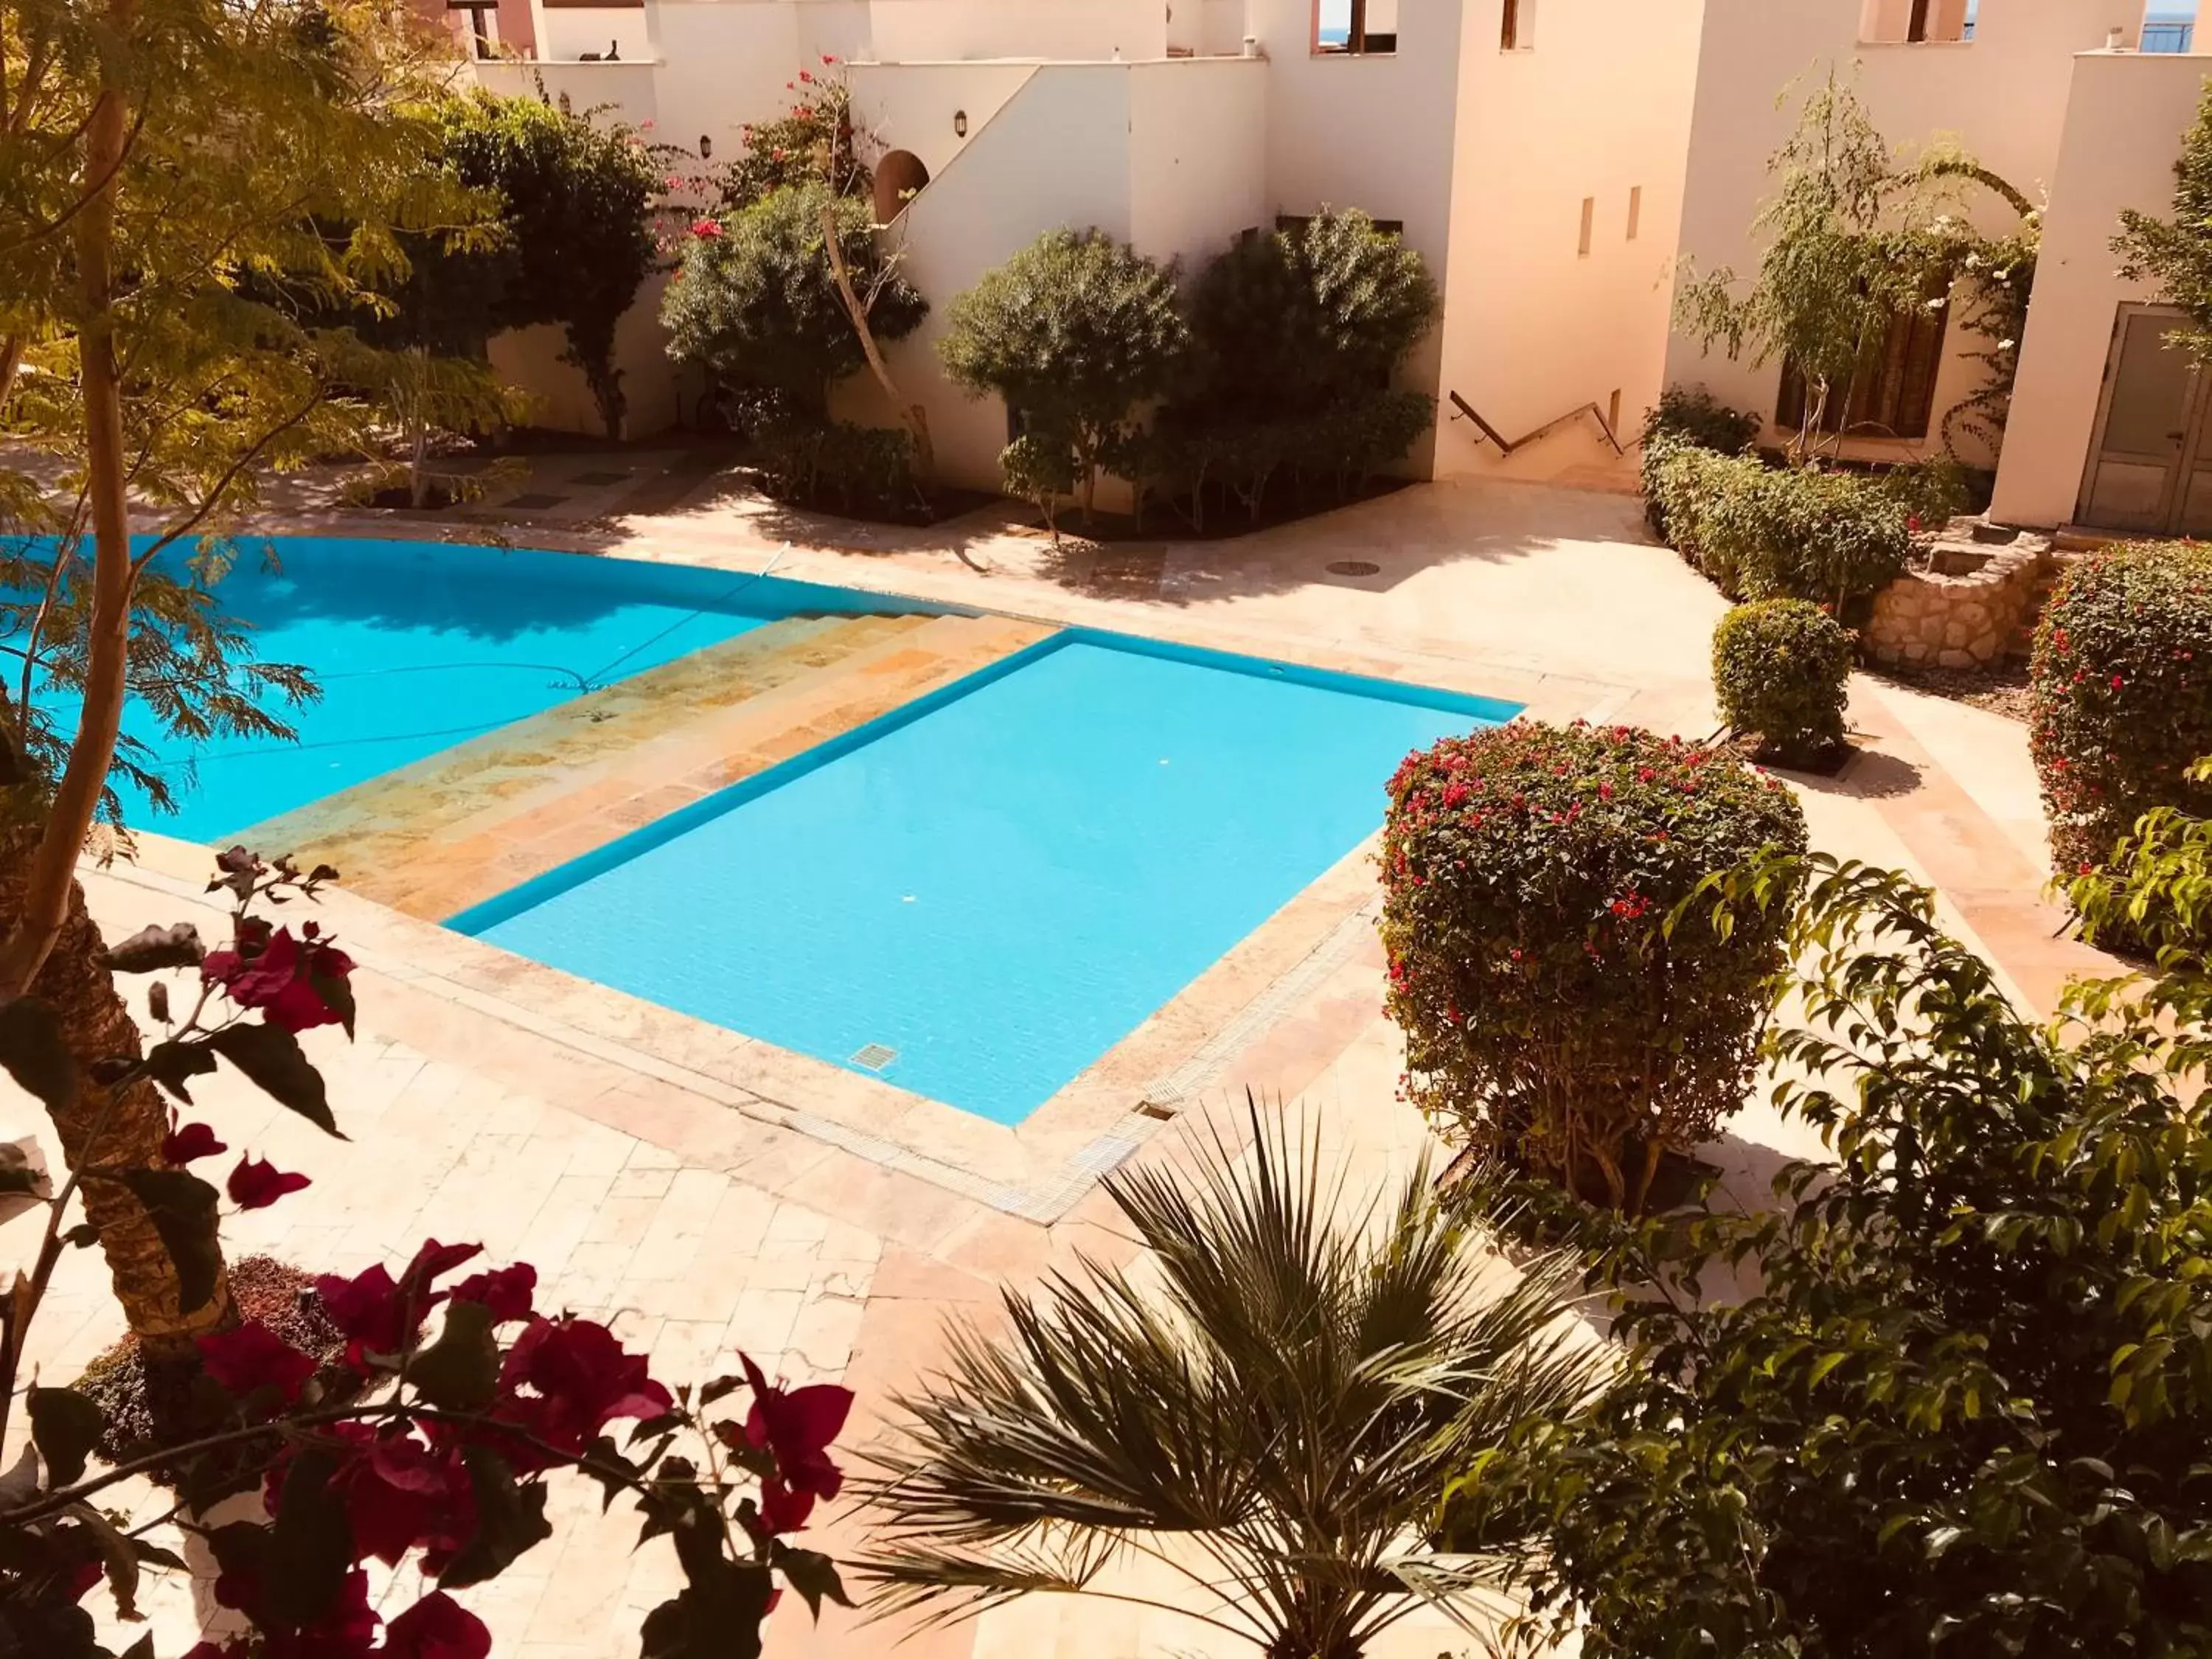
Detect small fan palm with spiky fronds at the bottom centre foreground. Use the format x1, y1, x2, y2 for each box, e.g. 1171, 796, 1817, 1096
860, 1102, 1593, 1659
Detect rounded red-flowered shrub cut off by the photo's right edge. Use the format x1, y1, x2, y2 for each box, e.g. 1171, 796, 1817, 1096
2028, 542, 2212, 874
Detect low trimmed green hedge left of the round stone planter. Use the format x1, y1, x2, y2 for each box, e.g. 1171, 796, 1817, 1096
1652, 440, 1913, 611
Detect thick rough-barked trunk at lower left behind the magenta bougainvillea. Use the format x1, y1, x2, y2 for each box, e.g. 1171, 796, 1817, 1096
0, 830, 237, 1371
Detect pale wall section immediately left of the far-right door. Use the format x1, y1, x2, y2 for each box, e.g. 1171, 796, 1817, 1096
1989, 53, 2212, 524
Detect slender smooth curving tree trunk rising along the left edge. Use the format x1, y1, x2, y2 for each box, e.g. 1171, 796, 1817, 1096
0, 58, 135, 995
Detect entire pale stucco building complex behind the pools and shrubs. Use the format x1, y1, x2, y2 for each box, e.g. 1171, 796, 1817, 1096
453, 0, 2212, 531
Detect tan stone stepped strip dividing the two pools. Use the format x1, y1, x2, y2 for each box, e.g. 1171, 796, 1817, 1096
237, 615, 1053, 920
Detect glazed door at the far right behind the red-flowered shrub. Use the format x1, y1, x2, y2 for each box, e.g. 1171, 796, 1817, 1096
2079, 305, 2212, 533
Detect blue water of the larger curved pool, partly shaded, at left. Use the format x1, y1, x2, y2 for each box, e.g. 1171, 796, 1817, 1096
19, 538, 933, 841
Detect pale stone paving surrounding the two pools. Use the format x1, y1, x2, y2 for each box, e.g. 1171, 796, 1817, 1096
0, 465, 2101, 1659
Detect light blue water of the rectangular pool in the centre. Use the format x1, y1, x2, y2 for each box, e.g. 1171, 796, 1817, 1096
451, 633, 1517, 1124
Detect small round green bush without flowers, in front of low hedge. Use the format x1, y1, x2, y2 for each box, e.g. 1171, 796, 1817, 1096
1712, 599, 1851, 768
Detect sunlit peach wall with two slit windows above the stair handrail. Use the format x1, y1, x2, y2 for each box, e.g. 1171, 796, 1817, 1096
1436, 0, 1699, 478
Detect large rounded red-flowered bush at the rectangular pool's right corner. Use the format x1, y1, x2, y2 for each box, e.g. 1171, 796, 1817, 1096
1382, 721, 1805, 1210
